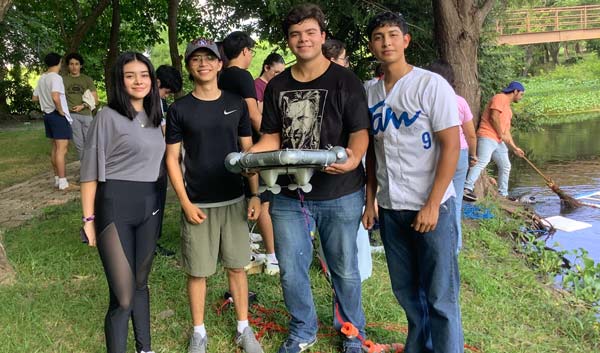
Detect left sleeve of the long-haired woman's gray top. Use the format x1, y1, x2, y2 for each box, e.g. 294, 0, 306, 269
79, 109, 110, 182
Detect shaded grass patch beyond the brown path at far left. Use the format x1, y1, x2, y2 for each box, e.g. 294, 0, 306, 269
0, 120, 77, 189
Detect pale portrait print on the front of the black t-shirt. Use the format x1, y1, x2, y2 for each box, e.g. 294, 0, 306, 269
279, 89, 327, 149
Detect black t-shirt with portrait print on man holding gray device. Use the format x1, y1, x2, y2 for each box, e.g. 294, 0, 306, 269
261, 64, 370, 200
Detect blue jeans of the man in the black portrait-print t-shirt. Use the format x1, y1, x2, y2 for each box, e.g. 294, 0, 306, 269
270, 190, 366, 347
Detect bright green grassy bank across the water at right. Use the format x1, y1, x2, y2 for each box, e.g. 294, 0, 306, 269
513, 53, 600, 130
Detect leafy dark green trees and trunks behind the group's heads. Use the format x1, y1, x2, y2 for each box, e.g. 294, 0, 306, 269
0, 0, 597, 117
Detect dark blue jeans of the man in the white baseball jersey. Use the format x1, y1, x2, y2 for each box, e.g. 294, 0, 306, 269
379, 198, 464, 353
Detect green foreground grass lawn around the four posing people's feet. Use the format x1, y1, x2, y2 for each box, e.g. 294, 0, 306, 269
0, 199, 600, 353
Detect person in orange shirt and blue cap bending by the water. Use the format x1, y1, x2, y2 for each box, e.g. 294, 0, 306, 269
463, 81, 525, 201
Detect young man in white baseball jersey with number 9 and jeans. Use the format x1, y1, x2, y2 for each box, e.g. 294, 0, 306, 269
363, 12, 463, 353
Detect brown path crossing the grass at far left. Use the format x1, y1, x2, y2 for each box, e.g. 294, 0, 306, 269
0, 162, 79, 285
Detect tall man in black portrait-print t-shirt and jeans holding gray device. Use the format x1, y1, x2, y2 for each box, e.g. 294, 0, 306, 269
251, 4, 369, 353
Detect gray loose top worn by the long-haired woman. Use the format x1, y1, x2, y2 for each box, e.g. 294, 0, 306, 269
80, 107, 165, 182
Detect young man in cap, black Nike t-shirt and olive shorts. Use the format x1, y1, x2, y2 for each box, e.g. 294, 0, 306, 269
166, 38, 263, 353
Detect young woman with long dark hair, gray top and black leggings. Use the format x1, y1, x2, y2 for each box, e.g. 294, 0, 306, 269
81, 52, 165, 353
